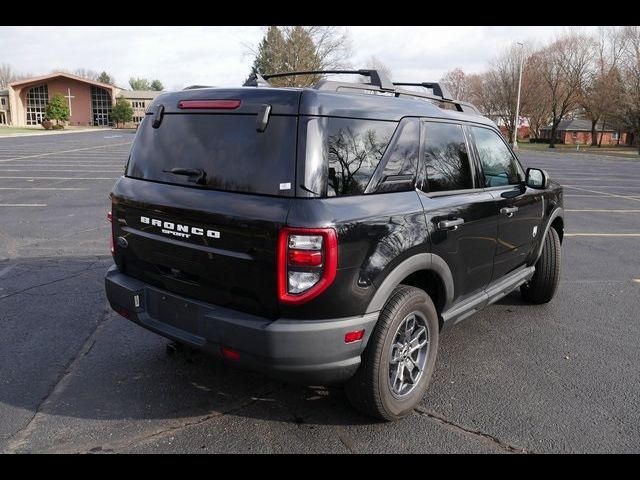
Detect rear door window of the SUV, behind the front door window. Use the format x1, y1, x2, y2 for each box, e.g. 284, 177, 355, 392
423, 122, 473, 192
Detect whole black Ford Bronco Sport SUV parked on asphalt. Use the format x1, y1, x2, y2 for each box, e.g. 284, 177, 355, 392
106, 70, 564, 420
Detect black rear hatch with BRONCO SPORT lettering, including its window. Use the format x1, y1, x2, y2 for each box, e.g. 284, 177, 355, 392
112, 88, 300, 317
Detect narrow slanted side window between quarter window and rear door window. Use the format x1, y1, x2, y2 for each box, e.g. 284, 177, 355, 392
373, 118, 420, 193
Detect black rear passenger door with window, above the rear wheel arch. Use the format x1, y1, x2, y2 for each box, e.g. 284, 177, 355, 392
419, 121, 498, 302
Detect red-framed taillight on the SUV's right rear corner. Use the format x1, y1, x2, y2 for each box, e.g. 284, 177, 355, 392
278, 228, 338, 305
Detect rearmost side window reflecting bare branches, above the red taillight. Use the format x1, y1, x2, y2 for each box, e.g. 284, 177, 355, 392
326, 118, 397, 197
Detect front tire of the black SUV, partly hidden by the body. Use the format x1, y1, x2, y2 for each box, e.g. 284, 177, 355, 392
520, 227, 561, 305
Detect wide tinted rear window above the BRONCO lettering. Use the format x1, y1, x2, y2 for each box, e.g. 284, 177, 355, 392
127, 114, 297, 196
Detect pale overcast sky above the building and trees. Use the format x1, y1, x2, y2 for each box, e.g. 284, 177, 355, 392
0, 26, 595, 89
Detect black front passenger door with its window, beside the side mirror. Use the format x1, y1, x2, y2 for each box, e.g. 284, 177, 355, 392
470, 126, 543, 280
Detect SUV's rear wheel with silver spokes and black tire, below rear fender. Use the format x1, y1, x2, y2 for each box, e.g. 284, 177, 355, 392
345, 285, 439, 421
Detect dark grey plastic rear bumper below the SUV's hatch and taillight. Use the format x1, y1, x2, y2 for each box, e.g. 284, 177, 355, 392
105, 266, 378, 385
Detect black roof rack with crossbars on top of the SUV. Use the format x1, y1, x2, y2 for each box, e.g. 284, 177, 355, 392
244, 69, 480, 115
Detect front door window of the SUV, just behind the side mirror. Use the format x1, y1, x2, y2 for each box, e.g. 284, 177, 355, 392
471, 127, 524, 187
